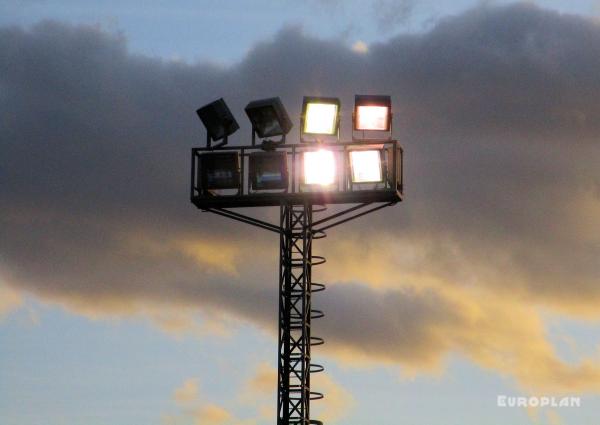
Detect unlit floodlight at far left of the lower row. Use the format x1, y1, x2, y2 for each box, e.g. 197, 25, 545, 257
200, 152, 240, 190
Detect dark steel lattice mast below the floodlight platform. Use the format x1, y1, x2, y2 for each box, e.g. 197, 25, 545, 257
277, 204, 325, 425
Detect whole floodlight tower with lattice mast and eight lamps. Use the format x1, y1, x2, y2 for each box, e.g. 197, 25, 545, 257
190, 95, 403, 425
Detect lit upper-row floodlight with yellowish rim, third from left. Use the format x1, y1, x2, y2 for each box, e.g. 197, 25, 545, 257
302, 97, 340, 136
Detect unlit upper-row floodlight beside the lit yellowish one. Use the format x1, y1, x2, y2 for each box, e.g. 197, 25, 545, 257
245, 97, 292, 138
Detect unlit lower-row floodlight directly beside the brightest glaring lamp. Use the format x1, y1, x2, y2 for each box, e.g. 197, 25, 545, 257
249, 151, 289, 190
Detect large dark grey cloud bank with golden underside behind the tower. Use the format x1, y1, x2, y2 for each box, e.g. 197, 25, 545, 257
0, 4, 600, 391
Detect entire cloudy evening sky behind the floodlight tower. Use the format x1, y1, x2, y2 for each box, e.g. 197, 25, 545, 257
0, 0, 600, 425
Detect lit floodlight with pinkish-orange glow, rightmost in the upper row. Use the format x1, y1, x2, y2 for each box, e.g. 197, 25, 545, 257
354, 95, 392, 131
